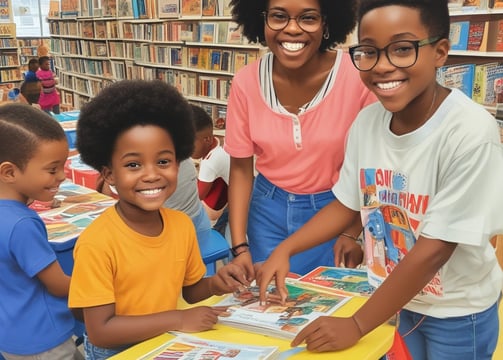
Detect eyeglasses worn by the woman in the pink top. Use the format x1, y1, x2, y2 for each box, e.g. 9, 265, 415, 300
262, 10, 324, 33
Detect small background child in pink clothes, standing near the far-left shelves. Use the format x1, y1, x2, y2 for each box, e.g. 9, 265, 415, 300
36, 56, 60, 114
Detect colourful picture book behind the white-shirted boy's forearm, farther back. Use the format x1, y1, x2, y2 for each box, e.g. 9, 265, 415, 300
297, 266, 375, 296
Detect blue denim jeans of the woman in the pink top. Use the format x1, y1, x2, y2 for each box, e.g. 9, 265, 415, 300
247, 174, 335, 274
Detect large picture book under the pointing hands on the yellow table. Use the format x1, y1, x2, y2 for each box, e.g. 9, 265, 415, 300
215, 283, 351, 340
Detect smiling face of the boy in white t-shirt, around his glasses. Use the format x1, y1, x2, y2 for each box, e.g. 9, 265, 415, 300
359, 5, 449, 121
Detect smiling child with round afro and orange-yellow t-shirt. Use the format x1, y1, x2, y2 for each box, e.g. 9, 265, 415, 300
69, 80, 244, 359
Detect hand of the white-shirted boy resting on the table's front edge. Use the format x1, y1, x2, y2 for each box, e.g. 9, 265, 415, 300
291, 316, 361, 352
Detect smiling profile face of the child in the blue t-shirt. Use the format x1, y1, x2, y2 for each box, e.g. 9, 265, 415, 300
6, 139, 68, 203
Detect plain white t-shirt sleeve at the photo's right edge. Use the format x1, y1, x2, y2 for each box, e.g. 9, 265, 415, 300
421, 143, 503, 246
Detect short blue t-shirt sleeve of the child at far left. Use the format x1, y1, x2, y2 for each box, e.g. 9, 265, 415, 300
10, 218, 56, 277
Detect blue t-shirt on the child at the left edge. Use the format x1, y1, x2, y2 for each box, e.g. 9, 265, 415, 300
0, 199, 75, 355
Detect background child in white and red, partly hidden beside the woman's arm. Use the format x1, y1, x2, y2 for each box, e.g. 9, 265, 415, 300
192, 105, 230, 235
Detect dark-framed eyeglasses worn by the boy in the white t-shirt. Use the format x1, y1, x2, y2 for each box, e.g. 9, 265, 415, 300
349, 36, 441, 71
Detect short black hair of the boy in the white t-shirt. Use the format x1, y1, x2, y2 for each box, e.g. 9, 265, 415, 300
358, 0, 450, 39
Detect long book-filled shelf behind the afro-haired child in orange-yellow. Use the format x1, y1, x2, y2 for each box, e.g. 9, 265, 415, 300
48, 0, 266, 135
